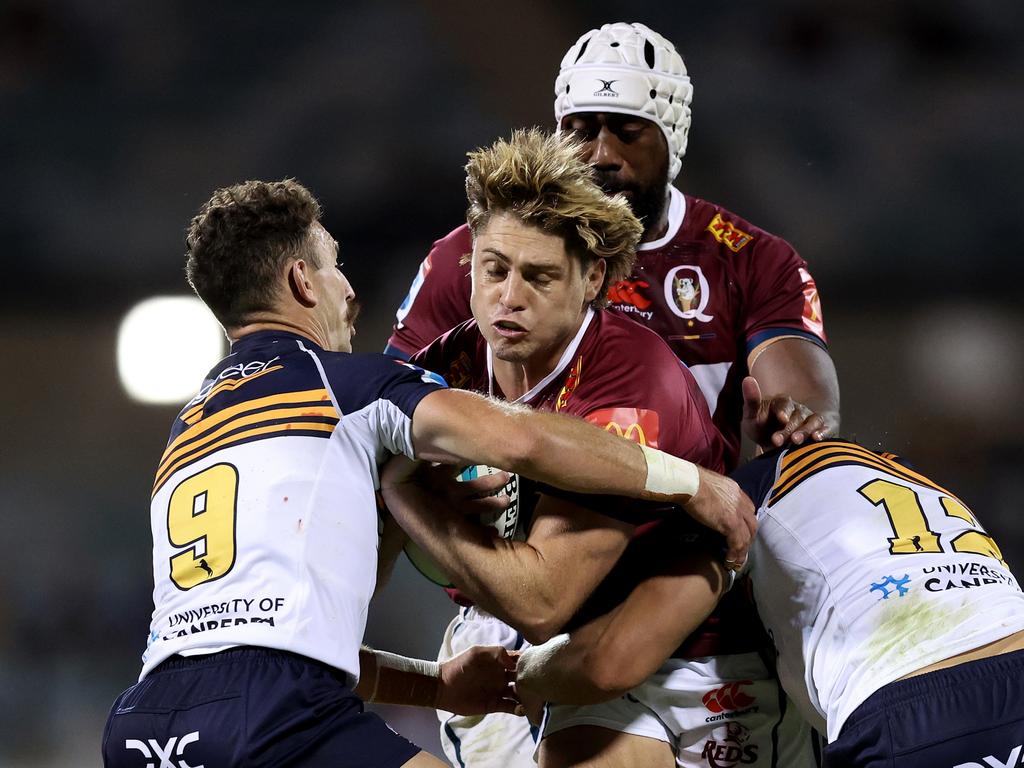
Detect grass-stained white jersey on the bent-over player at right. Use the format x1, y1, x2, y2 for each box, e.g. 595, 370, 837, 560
734, 440, 1024, 741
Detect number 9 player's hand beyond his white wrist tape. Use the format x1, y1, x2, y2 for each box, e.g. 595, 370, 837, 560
683, 467, 758, 570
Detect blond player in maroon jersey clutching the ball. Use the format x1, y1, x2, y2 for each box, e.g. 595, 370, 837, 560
381, 130, 786, 766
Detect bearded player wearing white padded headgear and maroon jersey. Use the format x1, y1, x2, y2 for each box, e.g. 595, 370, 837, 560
387, 24, 840, 469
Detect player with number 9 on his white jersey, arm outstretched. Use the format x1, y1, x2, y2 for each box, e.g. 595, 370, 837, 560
102, 180, 754, 768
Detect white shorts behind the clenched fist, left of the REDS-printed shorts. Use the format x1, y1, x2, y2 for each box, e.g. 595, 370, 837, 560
437, 607, 540, 768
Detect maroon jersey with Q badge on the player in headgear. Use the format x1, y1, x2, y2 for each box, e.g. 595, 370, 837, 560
388, 187, 825, 470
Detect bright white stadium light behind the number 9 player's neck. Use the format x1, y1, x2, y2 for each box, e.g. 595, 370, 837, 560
118, 296, 225, 406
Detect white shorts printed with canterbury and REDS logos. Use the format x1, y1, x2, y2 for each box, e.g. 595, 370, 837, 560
542, 653, 820, 768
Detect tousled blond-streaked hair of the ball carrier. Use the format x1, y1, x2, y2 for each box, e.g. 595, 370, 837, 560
466, 128, 643, 306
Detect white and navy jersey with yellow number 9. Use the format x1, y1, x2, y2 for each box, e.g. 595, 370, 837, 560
140, 332, 443, 684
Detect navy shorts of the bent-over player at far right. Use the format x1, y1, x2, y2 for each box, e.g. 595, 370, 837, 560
825, 650, 1024, 768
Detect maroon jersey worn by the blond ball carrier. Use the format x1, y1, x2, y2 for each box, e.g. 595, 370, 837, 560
413, 310, 757, 655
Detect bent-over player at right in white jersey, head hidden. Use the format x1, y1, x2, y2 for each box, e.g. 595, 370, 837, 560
517, 380, 1024, 768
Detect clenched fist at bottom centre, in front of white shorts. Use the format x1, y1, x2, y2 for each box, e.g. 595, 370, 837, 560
434, 645, 519, 715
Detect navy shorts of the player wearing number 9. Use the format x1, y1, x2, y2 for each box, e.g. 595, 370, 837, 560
102, 648, 420, 768
